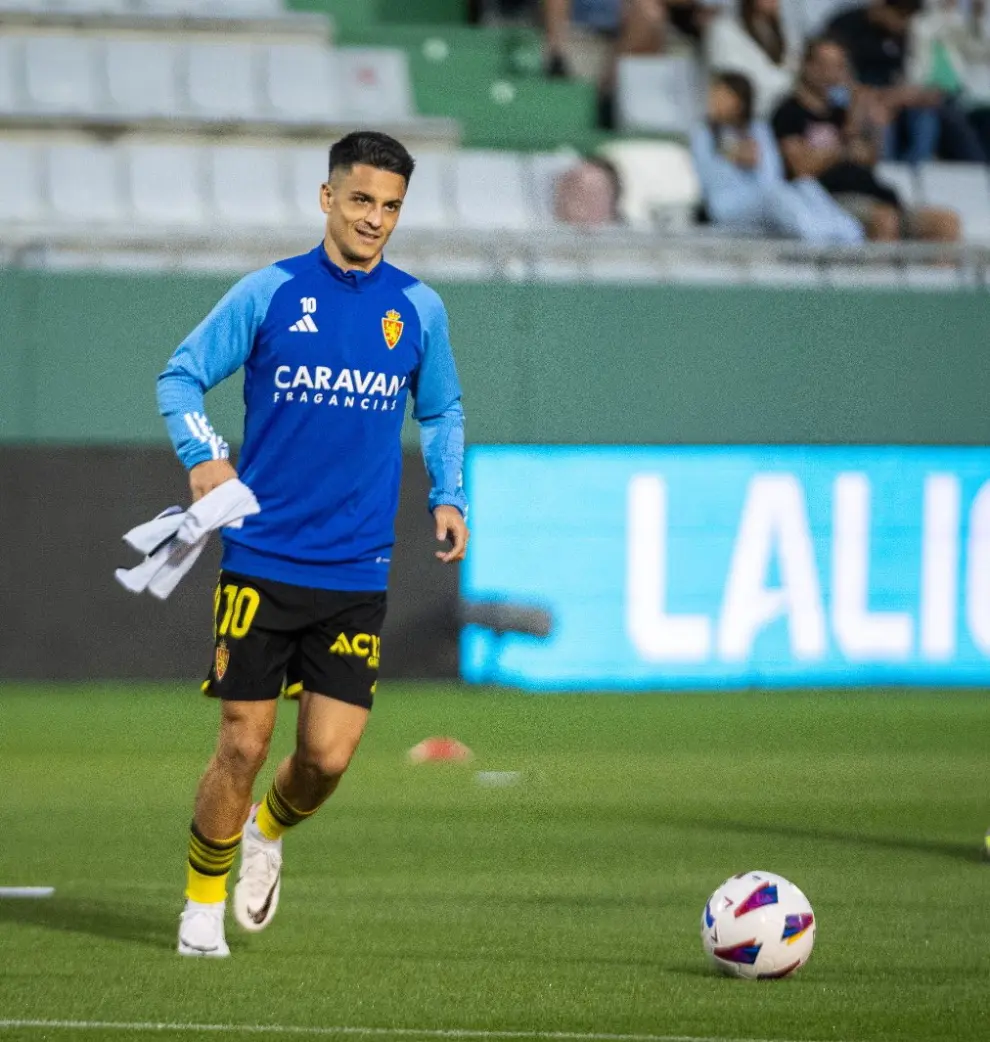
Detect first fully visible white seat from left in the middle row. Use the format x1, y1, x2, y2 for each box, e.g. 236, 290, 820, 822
24, 35, 100, 116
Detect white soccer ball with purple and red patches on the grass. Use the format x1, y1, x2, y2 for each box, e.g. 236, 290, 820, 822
701, 872, 815, 981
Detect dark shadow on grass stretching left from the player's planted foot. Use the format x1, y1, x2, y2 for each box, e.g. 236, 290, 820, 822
0, 897, 172, 950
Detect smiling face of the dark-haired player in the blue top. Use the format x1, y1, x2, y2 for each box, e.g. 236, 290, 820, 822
320, 164, 406, 270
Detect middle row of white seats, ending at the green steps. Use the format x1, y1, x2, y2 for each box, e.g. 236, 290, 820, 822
0, 31, 456, 144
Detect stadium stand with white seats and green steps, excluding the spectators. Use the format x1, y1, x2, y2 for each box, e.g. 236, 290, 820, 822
0, 0, 990, 286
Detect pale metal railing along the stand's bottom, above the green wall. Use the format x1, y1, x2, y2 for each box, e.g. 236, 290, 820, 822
0, 226, 990, 290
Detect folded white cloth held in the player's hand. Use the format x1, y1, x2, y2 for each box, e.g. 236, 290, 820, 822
114, 479, 262, 600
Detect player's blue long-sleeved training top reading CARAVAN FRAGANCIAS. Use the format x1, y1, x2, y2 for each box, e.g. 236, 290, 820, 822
158, 243, 467, 590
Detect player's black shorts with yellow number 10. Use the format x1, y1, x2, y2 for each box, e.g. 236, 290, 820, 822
203, 572, 386, 709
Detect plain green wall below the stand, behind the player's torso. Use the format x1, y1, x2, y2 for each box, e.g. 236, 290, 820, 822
0, 270, 990, 446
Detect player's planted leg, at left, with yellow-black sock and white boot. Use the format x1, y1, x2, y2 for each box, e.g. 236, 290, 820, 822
178, 701, 276, 958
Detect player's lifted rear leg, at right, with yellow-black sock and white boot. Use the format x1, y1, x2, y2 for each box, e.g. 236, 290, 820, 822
233, 691, 368, 932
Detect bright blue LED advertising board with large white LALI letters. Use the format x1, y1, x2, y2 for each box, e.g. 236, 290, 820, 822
462, 447, 990, 689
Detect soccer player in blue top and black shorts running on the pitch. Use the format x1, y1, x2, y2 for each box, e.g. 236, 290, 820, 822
158, 131, 468, 957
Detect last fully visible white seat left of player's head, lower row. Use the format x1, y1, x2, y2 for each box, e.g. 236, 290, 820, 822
208, 146, 289, 227
